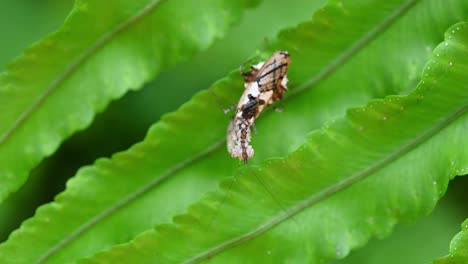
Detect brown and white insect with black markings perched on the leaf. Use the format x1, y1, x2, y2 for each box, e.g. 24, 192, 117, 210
227, 51, 291, 164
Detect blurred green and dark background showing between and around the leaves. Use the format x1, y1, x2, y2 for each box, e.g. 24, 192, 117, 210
0, 0, 468, 263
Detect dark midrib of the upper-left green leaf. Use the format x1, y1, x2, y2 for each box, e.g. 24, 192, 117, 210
0, 0, 164, 146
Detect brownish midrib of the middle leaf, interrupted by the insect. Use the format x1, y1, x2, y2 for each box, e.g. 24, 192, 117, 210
35, 0, 420, 263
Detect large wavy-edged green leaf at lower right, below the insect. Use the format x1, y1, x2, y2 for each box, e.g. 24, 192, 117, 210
80, 19, 468, 263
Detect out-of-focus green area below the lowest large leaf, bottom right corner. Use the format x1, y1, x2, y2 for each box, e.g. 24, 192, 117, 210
329, 186, 468, 264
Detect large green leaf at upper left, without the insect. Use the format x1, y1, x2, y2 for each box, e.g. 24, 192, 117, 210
0, 0, 256, 201
